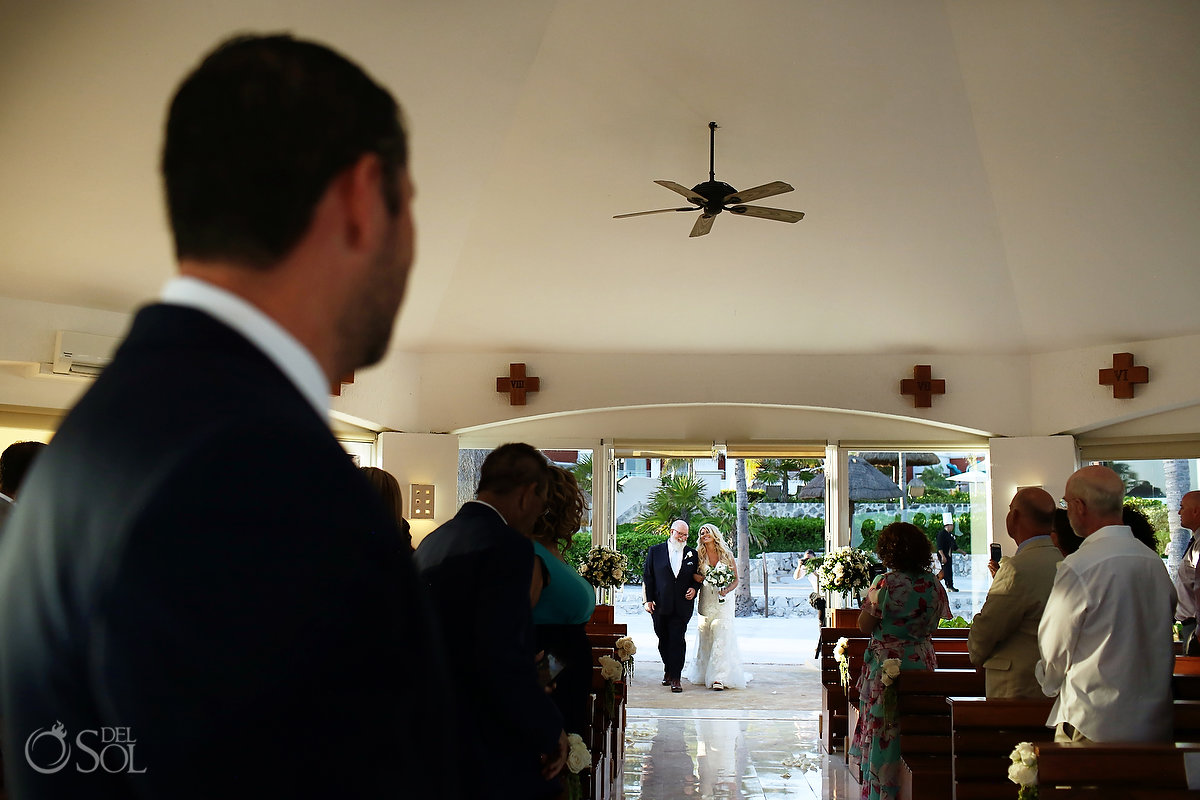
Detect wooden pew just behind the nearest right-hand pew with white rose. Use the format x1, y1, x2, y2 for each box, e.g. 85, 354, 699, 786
947, 697, 1054, 800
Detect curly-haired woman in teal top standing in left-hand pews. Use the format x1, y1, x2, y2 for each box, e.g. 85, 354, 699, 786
533, 465, 596, 734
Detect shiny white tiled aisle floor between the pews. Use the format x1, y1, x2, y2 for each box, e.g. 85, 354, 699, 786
625, 708, 858, 800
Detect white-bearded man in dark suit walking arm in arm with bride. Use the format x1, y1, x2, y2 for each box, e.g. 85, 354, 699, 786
642, 519, 700, 692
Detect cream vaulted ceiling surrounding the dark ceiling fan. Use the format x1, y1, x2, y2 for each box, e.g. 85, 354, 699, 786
0, 0, 1200, 354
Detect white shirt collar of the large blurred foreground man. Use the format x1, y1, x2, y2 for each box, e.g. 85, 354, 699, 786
161, 276, 329, 419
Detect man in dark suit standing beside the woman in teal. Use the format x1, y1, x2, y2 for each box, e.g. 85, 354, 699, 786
416, 444, 566, 800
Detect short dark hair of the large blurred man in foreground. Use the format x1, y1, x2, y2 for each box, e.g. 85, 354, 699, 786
162, 35, 408, 269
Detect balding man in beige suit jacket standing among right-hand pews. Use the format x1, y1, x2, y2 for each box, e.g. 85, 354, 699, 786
967, 487, 1062, 699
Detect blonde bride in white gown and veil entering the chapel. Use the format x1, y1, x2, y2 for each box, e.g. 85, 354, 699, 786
686, 524, 748, 691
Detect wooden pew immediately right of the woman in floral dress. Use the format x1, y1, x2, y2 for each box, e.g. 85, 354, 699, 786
896, 669, 984, 800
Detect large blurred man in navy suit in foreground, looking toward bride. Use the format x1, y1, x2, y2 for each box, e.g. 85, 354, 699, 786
0, 36, 458, 800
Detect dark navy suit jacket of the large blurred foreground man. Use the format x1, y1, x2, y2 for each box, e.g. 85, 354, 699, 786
0, 305, 456, 800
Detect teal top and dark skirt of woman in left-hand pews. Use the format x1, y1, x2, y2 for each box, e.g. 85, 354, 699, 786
533, 542, 596, 734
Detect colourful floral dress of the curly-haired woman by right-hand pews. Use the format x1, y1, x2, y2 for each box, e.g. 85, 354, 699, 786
848, 570, 950, 800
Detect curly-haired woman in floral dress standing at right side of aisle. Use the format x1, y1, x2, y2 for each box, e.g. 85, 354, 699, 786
848, 522, 950, 800
